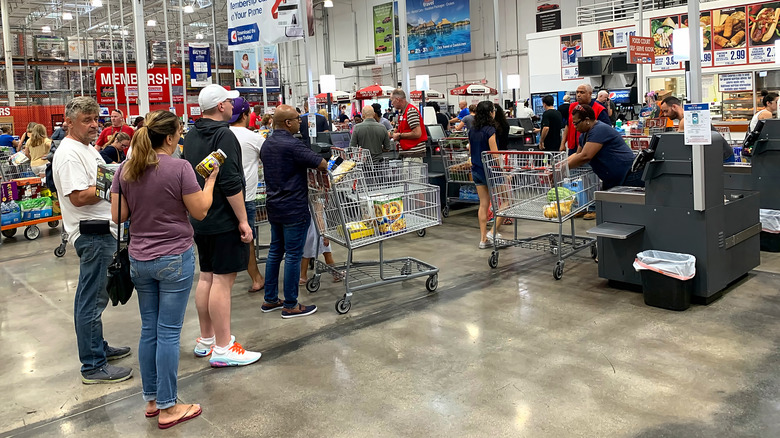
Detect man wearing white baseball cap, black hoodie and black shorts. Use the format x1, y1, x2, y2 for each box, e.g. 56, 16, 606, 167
184, 84, 260, 367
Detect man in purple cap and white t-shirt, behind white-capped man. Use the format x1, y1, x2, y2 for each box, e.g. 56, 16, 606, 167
230, 97, 265, 292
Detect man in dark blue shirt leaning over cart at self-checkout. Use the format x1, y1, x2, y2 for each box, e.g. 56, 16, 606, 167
569, 104, 645, 190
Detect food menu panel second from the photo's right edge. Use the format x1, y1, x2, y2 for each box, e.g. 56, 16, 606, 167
711, 6, 748, 67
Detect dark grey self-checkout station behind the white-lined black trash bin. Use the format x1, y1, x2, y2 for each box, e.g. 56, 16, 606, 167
588, 132, 761, 304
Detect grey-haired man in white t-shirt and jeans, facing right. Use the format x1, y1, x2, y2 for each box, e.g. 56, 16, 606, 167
52, 97, 133, 384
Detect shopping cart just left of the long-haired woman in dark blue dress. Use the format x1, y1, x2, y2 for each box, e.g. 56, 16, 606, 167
441, 138, 479, 218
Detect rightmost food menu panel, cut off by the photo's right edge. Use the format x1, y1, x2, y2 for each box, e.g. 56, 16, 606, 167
747, 2, 780, 64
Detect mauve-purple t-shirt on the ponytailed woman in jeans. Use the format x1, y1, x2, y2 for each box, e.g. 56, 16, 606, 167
111, 154, 200, 261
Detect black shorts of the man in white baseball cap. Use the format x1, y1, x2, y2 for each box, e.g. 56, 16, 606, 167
195, 229, 249, 274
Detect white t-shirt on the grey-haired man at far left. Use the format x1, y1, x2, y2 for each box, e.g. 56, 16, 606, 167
52, 137, 116, 244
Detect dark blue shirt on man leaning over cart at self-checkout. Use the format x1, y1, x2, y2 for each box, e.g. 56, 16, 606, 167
580, 120, 634, 190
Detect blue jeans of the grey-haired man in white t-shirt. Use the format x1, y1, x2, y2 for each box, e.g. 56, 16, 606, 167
73, 234, 116, 373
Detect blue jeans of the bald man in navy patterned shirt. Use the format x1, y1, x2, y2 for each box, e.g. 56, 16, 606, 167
265, 219, 309, 309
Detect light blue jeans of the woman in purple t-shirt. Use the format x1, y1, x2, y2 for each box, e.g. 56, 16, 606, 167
130, 247, 195, 409
